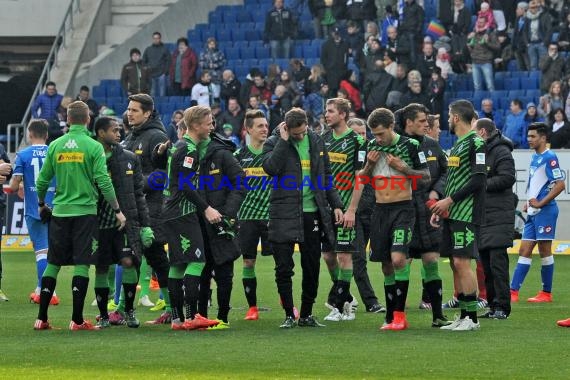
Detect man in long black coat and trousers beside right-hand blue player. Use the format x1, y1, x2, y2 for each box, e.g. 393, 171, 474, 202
474, 119, 516, 319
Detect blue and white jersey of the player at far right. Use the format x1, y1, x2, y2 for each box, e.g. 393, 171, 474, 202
526, 149, 565, 203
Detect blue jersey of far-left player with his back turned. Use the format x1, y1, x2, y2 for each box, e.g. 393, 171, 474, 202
13, 145, 55, 219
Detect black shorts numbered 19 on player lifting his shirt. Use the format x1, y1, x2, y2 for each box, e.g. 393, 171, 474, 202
370, 201, 416, 262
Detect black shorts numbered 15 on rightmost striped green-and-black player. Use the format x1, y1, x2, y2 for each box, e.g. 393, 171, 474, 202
440, 219, 479, 259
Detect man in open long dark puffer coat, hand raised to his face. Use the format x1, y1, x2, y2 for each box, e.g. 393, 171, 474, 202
263, 108, 343, 328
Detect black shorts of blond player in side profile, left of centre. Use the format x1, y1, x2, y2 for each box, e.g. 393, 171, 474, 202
162, 213, 206, 265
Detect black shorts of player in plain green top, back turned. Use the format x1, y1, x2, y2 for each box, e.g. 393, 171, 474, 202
48, 215, 99, 266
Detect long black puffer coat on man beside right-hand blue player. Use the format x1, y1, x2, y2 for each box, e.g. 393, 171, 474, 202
479, 131, 516, 249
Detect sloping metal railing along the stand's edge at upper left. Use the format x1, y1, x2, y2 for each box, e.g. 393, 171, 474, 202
6, 0, 81, 153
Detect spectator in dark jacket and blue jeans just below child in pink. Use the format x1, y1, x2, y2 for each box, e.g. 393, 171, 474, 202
467, 17, 499, 91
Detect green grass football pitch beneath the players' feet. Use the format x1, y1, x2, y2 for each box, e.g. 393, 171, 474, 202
0, 252, 570, 379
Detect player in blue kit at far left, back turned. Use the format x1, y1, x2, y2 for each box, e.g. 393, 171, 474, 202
10, 119, 59, 305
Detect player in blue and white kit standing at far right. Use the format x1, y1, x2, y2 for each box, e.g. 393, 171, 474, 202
511, 123, 566, 302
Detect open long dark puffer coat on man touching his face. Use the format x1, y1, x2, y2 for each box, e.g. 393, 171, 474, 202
263, 128, 343, 244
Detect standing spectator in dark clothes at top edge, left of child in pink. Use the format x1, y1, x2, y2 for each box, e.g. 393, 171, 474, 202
446, 0, 471, 73
